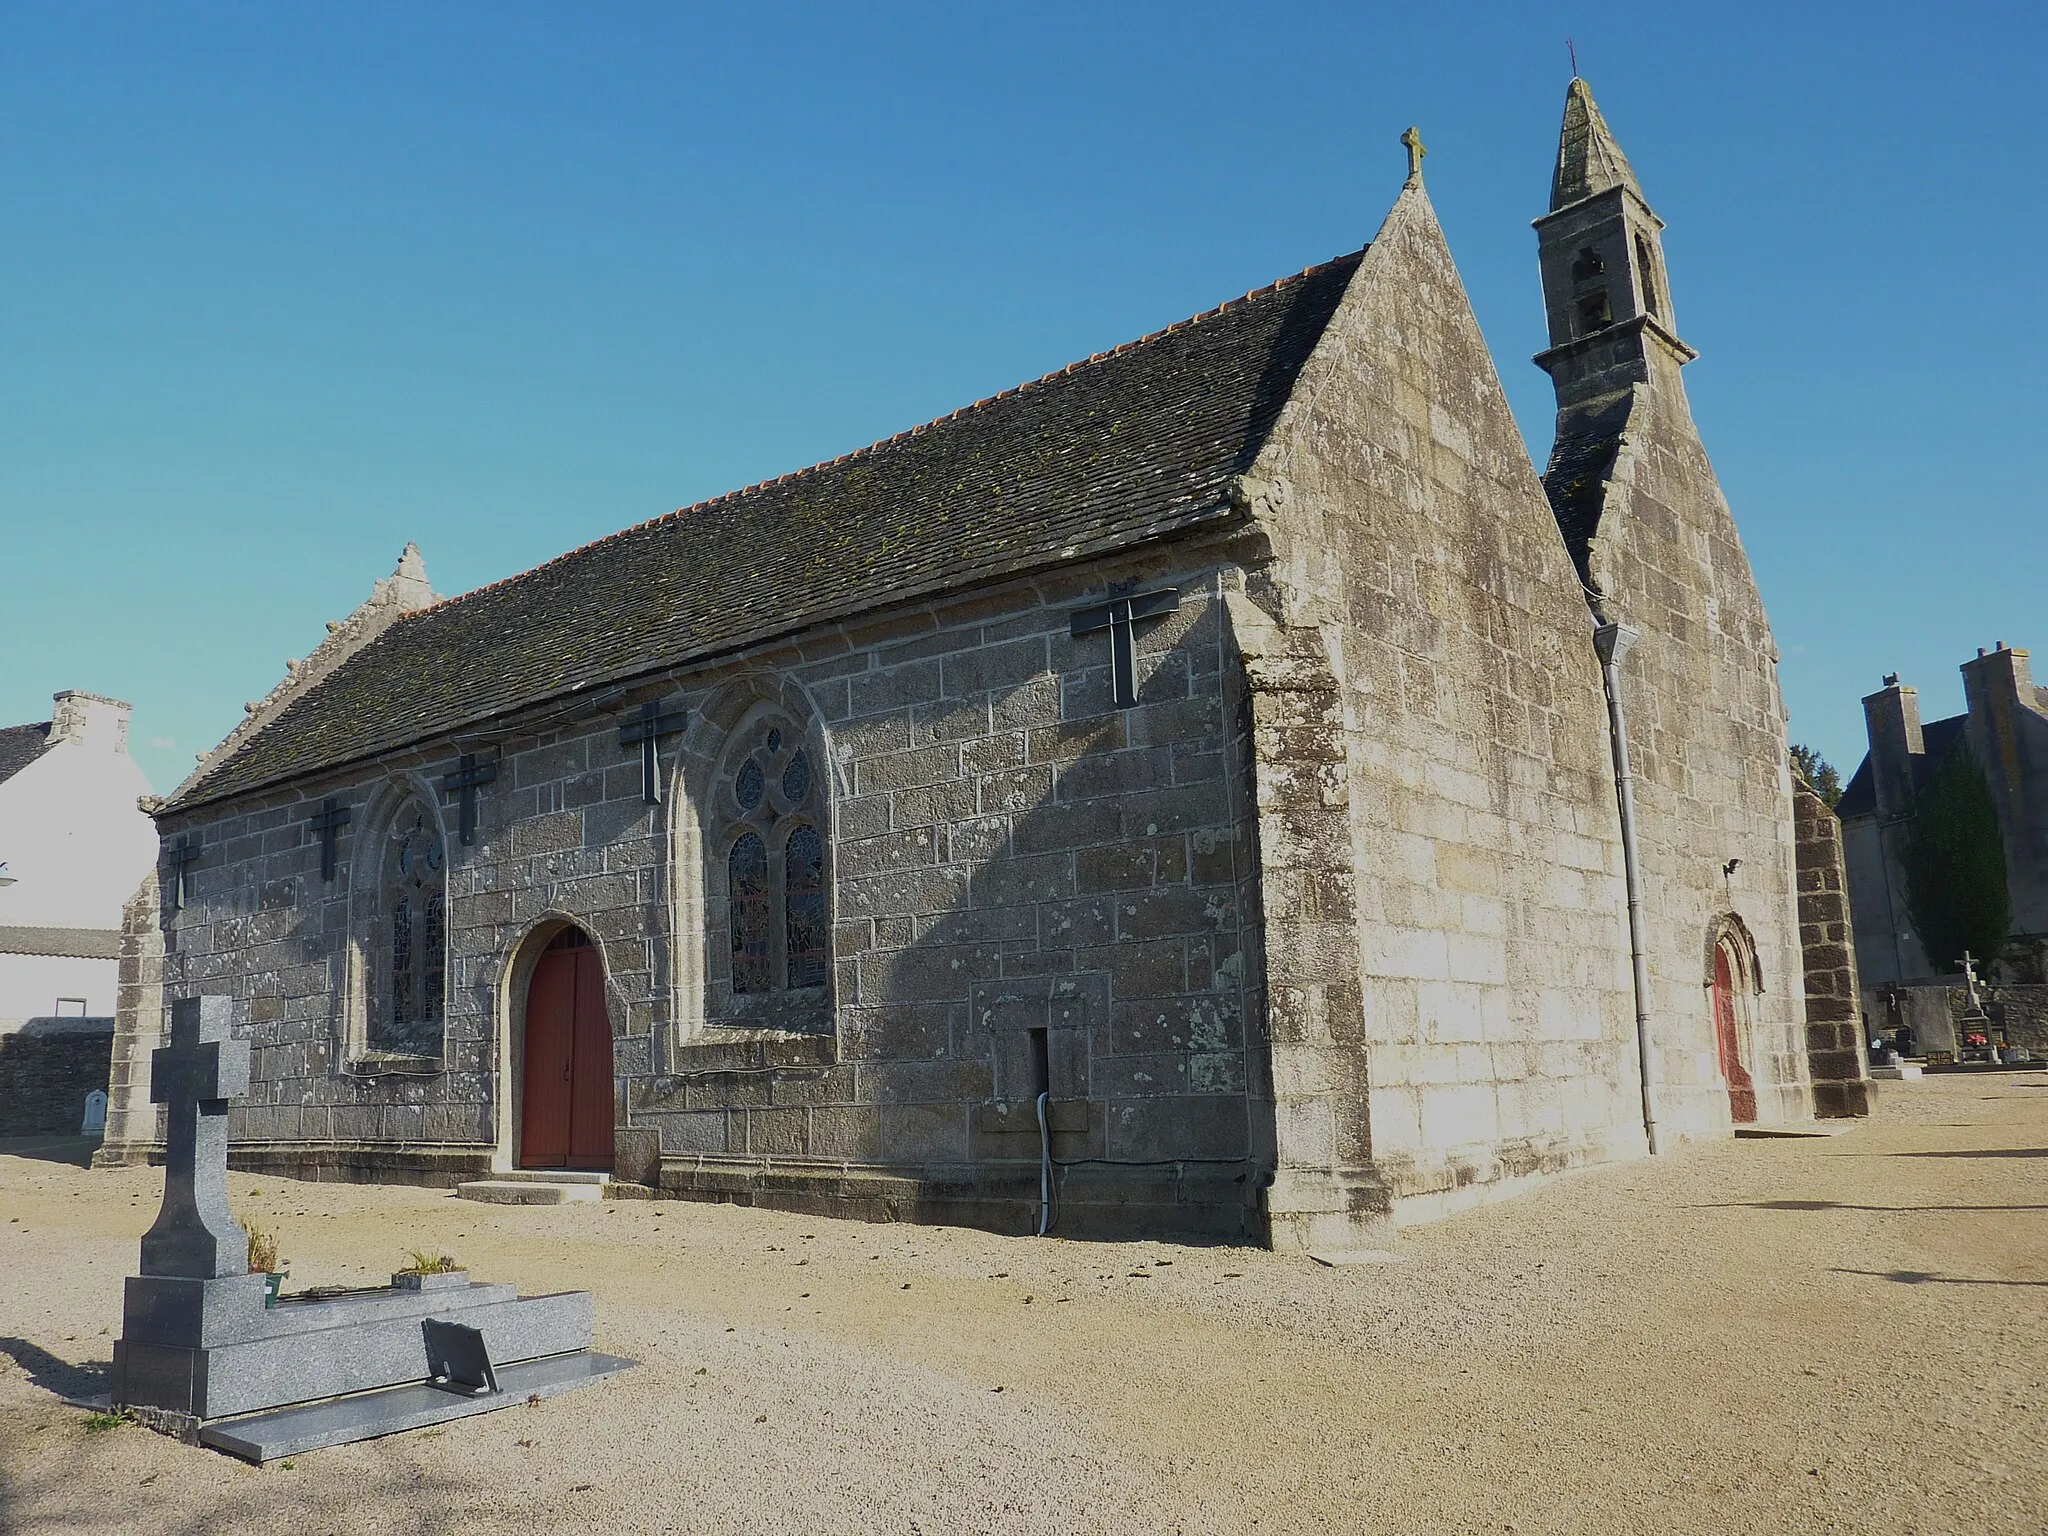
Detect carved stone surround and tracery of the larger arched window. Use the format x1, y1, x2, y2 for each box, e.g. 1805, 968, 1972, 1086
670, 672, 846, 1042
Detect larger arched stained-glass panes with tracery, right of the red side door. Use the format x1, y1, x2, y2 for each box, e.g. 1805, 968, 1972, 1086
713, 721, 831, 1028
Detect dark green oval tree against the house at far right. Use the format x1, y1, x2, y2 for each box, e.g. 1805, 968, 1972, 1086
1901, 743, 2013, 973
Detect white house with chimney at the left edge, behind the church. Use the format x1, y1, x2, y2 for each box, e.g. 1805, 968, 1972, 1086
0, 690, 158, 1034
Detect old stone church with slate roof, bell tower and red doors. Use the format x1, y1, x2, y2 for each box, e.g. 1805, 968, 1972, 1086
99, 80, 1859, 1249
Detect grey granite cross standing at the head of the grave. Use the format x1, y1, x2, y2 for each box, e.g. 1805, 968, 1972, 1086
141, 997, 250, 1280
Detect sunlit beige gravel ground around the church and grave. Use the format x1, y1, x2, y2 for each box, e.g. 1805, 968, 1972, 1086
0, 1073, 2048, 1536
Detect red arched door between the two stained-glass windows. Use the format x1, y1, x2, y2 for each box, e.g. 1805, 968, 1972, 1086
518, 928, 612, 1169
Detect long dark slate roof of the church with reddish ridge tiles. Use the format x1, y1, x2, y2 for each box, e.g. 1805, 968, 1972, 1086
166, 252, 1364, 811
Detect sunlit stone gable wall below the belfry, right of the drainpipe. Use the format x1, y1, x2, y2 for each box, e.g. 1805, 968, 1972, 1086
1589, 366, 1812, 1137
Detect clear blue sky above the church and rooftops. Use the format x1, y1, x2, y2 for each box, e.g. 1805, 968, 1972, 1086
0, 0, 2048, 788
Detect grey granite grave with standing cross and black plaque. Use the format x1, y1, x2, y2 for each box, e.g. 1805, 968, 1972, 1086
111, 997, 633, 1460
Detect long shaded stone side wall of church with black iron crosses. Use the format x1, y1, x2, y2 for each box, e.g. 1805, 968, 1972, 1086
162, 547, 1270, 1237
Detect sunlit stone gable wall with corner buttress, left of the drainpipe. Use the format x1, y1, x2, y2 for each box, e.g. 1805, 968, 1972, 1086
1241, 190, 1642, 1247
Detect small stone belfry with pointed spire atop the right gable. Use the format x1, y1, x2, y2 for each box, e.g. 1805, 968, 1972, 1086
1536, 76, 1698, 416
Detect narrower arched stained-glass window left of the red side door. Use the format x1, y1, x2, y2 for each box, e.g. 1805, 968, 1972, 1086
380, 801, 449, 1057
